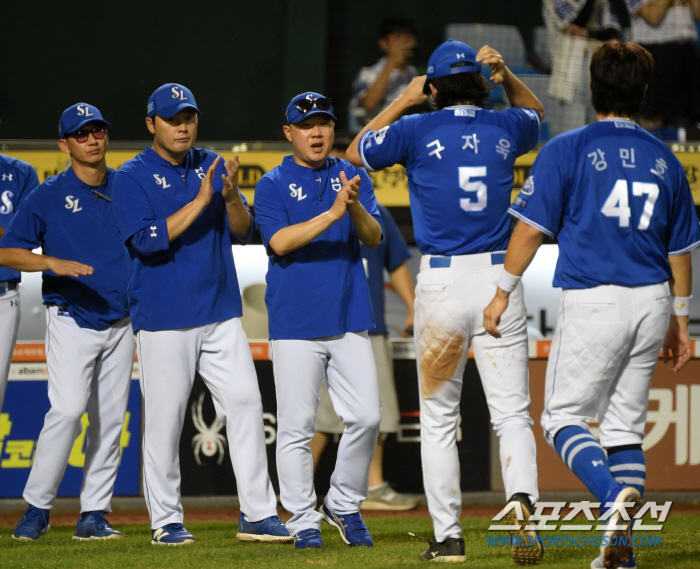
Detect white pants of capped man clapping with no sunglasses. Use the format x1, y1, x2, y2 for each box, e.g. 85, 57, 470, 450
137, 318, 277, 529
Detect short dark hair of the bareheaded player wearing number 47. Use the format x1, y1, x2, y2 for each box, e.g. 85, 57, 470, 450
591, 40, 654, 117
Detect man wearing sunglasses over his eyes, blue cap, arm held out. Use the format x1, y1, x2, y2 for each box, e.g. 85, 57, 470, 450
0, 103, 135, 540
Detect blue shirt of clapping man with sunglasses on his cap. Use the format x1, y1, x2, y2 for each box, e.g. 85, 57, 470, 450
255, 156, 381, 340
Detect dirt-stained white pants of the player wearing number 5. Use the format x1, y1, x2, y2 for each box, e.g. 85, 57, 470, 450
414, 253, 539, 541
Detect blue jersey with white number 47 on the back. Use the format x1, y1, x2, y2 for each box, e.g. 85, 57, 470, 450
510, 119, 700, 289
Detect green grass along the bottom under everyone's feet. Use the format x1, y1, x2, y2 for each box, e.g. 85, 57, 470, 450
0, 515, 700, 569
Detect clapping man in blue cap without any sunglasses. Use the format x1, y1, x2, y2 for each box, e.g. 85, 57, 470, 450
112, 83, 291, 545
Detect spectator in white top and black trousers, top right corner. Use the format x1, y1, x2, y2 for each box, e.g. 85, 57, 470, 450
626, 0, 700, 130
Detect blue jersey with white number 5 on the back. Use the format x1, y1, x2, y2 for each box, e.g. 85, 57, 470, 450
359, 105, 540, 255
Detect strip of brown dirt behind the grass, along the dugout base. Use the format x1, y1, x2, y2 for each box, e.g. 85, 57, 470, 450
0, 504, 700, 527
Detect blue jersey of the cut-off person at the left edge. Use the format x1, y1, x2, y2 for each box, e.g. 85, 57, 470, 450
0, 154, 39, 282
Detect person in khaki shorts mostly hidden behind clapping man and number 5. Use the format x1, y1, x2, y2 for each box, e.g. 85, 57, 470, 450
311, 203, 418, 510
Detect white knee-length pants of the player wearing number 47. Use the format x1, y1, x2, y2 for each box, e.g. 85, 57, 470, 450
542, 283, 671, 448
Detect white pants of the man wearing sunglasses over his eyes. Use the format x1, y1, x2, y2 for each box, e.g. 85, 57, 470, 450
24, 306, 134, 512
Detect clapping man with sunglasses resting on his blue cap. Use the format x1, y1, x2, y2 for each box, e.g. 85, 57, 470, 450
255, 92, 381, 549
